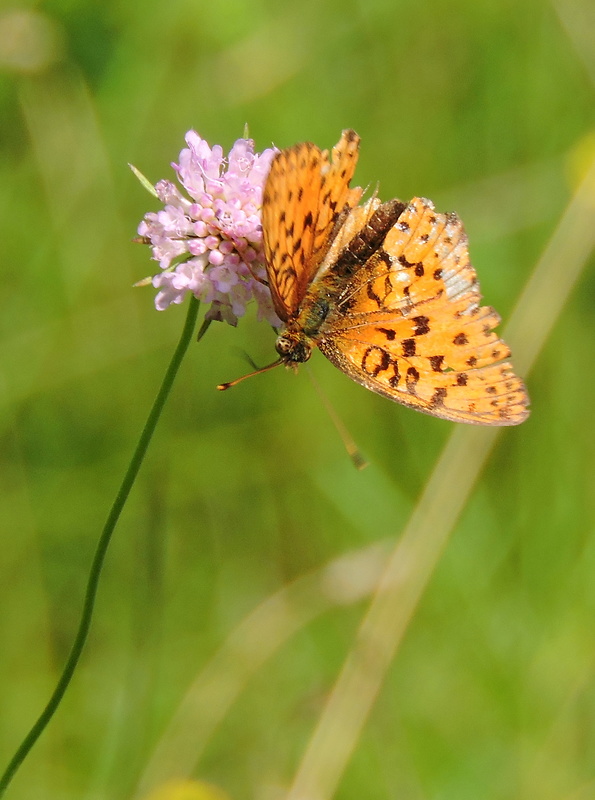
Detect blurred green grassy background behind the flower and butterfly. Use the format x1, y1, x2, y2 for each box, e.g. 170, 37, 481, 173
0, 0, 595, 800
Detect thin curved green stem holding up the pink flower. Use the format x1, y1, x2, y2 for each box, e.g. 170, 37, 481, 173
0, 297, 199, 797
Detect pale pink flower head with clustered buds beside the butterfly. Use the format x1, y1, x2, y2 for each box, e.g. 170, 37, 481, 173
138, 131, 280, 325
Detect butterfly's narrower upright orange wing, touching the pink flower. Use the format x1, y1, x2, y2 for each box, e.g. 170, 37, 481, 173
262, 130, 362, 320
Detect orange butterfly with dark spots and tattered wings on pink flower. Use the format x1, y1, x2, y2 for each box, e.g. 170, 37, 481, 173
222, 130, 529, 425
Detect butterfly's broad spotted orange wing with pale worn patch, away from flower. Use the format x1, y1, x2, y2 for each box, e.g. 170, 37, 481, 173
313, 198, 529, 425
